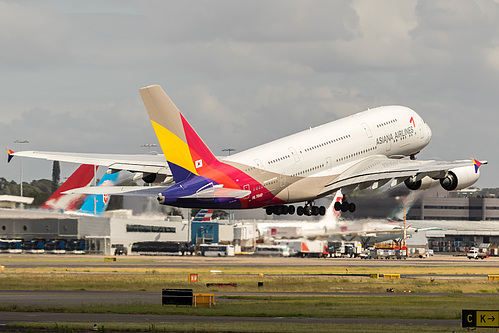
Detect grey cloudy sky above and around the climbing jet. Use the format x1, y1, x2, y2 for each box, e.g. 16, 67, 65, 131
0, 0, 499, 187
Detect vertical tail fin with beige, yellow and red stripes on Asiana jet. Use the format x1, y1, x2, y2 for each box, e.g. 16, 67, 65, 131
139, 85, 218, 183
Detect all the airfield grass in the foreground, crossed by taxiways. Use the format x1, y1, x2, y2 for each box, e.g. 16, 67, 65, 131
0, 260, 499, 332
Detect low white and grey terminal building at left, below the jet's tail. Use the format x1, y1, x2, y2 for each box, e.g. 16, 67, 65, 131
0, 209, 189, 255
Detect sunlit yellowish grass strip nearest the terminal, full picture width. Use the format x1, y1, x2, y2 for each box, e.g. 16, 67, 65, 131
0, 266, 499, 293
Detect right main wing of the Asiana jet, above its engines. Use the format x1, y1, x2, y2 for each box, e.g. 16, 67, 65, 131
322, 155, 480, 193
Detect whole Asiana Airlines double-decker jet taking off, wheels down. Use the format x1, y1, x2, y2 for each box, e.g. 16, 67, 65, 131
7, 85, 487, 216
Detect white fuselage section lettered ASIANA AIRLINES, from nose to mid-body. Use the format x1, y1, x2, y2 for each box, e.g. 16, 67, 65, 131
225, 106, 431, 177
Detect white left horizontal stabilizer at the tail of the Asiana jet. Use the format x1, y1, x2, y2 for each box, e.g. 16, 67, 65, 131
63, 186, 169, 197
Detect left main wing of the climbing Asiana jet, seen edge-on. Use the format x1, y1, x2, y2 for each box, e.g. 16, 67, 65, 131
9, 151, 171, 176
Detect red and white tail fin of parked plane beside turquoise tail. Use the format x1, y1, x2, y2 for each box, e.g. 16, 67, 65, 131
40, 164, 95, 211
